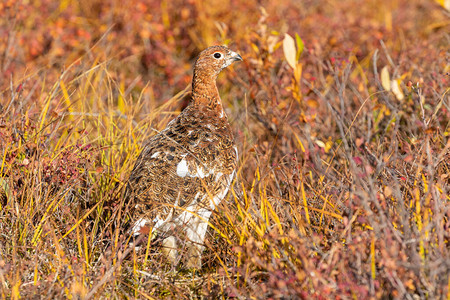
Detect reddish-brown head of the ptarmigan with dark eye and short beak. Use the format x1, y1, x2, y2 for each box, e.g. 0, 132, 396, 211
194, 46, 242, 76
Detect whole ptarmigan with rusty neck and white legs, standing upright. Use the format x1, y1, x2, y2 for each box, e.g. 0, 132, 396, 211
127, 46, 242, 268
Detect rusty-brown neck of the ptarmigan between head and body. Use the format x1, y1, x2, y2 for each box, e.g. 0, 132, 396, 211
192, 71, 223, 112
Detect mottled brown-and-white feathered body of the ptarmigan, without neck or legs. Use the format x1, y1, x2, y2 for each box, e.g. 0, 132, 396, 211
128, 106, 237, 224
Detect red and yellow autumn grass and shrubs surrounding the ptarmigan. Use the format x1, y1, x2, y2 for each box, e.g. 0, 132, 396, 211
0, 0, 450, 299
